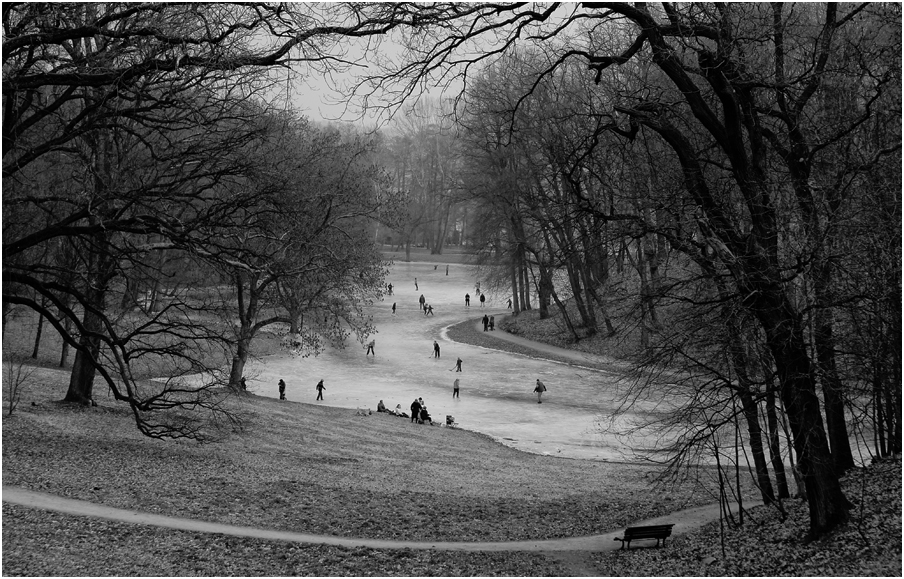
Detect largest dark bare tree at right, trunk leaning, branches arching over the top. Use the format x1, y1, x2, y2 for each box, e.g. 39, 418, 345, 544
361, 3, 900, 535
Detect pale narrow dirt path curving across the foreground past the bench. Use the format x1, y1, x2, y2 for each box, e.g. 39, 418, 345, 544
3, 486, 753, 558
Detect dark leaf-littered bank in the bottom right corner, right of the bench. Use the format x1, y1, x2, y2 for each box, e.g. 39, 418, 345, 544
591, 459, 901, 577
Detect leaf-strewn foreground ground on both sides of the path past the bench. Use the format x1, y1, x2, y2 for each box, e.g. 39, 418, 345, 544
2, 308, 901, 576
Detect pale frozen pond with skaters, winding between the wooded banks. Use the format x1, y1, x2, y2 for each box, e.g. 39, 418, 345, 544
245, 262, 668, 461
